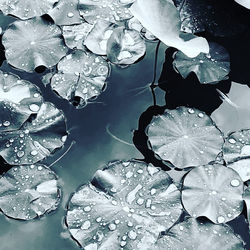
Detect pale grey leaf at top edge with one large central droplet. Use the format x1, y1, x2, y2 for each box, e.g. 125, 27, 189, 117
48, 0, 84, 25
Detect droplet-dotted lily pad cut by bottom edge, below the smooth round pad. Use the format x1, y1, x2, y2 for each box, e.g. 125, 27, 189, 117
156, 218, 245, 250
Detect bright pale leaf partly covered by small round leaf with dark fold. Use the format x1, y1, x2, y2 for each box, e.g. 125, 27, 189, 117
84, 20, 118, 55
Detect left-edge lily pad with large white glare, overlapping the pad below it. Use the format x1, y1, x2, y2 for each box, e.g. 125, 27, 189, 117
0, 71, 43, 133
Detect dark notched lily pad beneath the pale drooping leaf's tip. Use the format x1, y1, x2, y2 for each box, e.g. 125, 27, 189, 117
173, 43, 230, 83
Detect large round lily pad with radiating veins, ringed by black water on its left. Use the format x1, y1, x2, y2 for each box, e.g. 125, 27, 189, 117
146, 107, 224, 168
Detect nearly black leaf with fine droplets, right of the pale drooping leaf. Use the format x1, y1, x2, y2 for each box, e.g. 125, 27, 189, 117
174, 0, 249, 36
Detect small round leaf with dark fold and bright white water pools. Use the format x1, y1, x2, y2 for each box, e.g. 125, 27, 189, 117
107, 27, 146, 65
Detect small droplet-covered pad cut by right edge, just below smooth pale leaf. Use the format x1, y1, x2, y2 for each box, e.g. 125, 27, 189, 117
223, 129, 250, 164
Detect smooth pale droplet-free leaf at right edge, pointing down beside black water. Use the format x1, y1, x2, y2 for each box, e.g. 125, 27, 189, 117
211, 82, 250, 134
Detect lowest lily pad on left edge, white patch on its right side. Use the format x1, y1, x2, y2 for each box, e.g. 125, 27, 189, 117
0, 164, 60, 220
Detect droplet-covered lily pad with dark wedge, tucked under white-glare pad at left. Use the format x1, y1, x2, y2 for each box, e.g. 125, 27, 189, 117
0, 103, 67, 165
